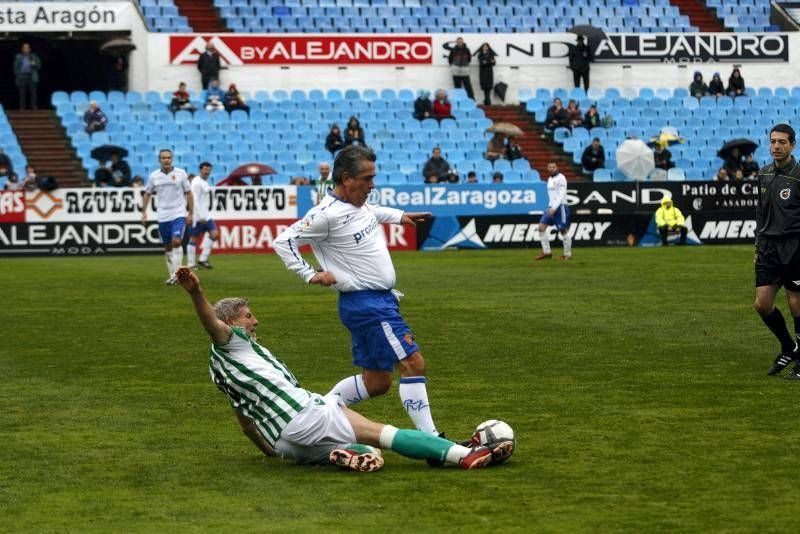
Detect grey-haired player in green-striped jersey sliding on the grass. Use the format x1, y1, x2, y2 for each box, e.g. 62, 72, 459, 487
176, 267, 514, 471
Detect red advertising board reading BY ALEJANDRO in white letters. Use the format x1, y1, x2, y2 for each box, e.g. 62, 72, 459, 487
169, 34, 433, 65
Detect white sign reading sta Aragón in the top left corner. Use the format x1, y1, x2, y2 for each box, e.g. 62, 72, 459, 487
0, 2, 138, 32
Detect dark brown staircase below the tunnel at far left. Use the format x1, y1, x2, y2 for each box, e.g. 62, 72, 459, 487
6, 110, 87, 187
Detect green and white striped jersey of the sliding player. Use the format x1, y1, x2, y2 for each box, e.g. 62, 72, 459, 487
208, 326, 311, 447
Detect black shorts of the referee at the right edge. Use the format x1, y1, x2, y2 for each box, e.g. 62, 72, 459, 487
756, 237, 800, 292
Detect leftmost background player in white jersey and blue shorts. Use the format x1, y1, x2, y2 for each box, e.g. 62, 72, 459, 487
142, 148, 193, 286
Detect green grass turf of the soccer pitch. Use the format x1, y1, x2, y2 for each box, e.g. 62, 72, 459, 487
0, 246, 800, 532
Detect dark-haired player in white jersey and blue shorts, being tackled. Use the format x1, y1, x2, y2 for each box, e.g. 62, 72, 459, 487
273, 145, 438, 440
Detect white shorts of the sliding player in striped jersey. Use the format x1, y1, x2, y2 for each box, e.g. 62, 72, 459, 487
275, 393, 356, 464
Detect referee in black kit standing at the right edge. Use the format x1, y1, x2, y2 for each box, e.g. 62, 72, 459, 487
753, 124, 800, 380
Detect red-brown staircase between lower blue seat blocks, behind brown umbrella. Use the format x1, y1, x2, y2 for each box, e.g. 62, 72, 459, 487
480, 106, 584, 182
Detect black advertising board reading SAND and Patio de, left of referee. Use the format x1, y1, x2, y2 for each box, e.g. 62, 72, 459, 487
567, 181, 758, 213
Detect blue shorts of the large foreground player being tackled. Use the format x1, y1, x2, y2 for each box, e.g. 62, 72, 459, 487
339, 290, 419, 371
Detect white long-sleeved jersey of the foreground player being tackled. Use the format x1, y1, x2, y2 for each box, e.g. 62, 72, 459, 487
273, 193, 403, 292
